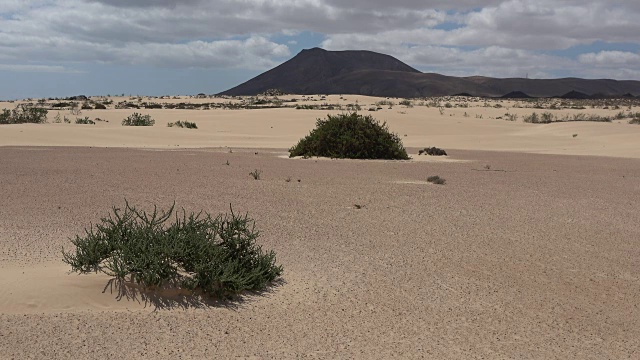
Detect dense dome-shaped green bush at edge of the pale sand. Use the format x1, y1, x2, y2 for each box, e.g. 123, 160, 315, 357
289, 113, 409, 160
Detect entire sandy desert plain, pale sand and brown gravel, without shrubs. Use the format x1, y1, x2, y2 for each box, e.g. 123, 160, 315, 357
0, 96, 640, 359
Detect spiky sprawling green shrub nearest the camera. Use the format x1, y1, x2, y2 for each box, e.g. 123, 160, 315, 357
62, 201, 282, 297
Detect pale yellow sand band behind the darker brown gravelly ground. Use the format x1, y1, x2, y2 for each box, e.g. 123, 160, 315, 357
0, 95, 640, 158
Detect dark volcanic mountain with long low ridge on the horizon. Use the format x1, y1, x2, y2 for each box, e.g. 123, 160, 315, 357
221, 48, 640, 98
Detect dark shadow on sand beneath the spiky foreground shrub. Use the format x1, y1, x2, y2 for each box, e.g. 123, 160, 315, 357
102, 278, 286, 310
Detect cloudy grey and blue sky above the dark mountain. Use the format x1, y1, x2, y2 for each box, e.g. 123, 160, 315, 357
0, 0, 640, 99
